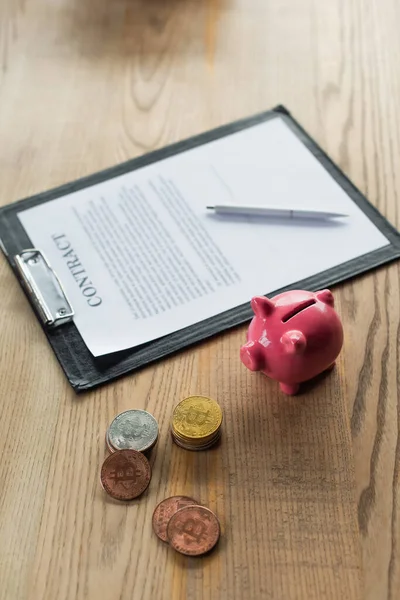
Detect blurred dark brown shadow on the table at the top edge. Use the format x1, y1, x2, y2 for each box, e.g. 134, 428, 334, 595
60, 0, 231, 61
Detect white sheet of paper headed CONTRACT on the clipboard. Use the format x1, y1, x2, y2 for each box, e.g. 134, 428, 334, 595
18, 118, 389, 356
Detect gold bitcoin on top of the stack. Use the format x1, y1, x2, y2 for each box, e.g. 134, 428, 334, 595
172, 396, 222, 441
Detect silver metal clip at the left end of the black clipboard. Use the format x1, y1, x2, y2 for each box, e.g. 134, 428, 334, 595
14, 249, 74, 327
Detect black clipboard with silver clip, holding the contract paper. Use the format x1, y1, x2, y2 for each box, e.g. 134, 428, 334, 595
0, 106, 400, 393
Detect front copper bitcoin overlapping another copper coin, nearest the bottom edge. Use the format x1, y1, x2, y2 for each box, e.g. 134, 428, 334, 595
167, 506, 221, 556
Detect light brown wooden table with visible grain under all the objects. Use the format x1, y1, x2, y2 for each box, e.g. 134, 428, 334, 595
0, 0, 400, 600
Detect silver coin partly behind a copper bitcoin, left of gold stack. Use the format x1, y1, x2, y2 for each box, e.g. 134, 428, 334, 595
107, 409, 158, 452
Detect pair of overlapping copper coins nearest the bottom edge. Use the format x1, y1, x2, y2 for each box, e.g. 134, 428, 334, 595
153, 496, 221, 556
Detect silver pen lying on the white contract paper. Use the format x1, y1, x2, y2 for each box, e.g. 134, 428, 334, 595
206, 204, 348, 219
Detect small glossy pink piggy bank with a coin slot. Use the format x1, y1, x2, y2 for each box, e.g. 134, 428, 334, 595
240, 290, 343, 394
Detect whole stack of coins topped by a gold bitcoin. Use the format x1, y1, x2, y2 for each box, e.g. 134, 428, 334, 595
171, 396, 222, 450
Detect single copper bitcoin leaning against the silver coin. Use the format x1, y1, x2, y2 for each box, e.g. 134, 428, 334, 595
100, 450, 151, 500
